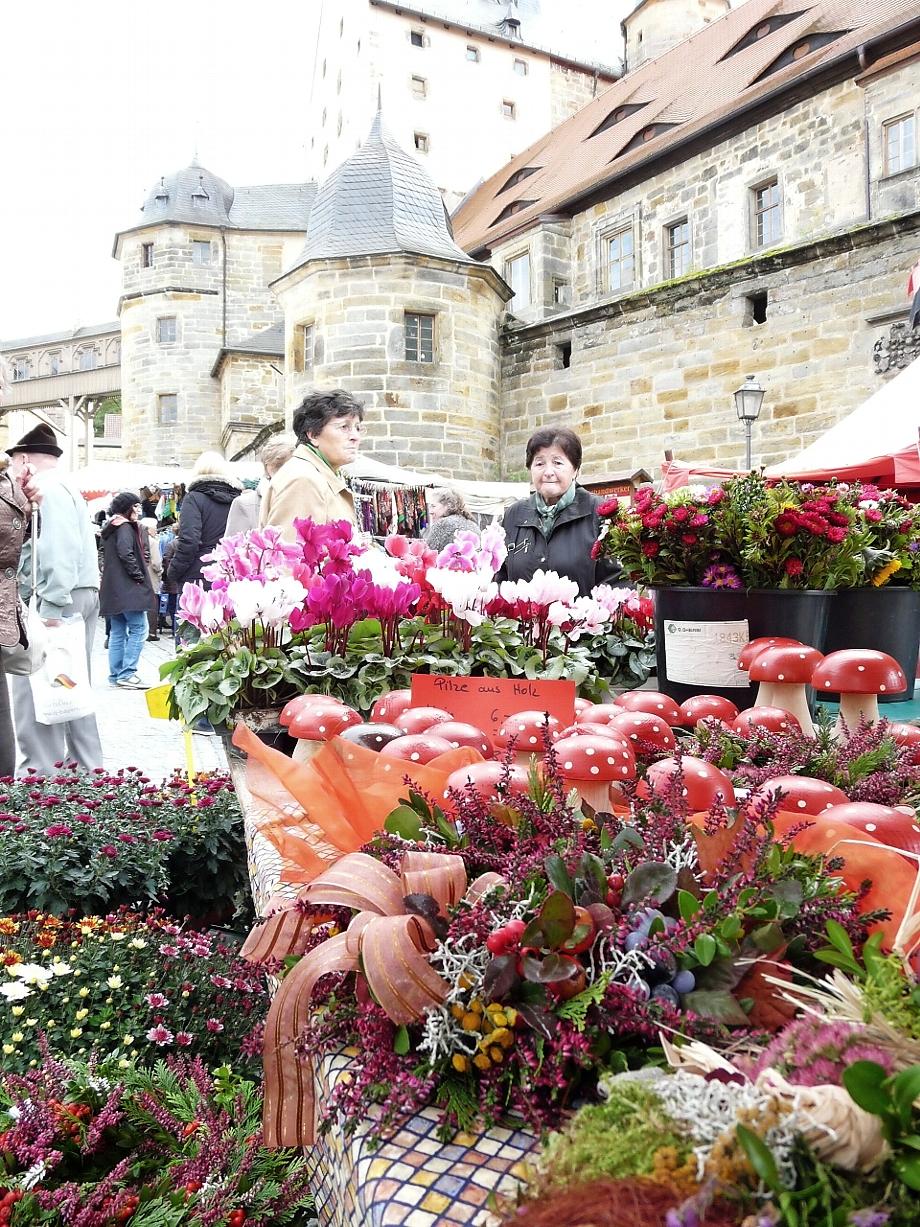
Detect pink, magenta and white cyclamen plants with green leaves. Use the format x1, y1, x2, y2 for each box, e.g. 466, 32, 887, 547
161, 520, 654, 726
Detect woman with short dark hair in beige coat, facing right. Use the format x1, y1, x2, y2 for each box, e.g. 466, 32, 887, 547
259, 390, 364, 541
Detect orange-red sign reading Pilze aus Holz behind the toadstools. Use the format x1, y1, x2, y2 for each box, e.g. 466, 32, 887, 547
412, 674, 575, 734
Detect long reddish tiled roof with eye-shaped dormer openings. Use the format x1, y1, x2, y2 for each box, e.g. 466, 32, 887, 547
453, 0, 920, 253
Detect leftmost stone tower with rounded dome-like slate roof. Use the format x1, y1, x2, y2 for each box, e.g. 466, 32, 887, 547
113, 162, 233, 463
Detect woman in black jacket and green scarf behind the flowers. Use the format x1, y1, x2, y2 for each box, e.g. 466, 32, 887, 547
497, 426, 619, 596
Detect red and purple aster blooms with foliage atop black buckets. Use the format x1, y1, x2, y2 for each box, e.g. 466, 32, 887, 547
597, 474, 920, 589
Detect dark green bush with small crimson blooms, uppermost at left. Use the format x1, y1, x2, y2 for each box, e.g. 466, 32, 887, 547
0, 764, 250, 921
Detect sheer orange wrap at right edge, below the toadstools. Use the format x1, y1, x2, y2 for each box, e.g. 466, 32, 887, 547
689, 810, 916, 948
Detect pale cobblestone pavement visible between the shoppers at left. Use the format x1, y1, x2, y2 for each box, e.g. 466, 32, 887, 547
13, 621, 227, 780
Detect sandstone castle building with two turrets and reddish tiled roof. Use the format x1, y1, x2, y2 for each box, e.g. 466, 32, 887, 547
0, 0, 920, 477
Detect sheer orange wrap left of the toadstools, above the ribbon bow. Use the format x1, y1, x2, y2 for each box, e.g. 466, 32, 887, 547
233, 723, 483, 885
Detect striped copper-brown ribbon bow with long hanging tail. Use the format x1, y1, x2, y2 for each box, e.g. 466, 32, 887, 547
242, 853, 502, 1146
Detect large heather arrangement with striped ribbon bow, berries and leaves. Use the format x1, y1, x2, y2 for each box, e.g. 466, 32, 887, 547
250, 748, 888, 1171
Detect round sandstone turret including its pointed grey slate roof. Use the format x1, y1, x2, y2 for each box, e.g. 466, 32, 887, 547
272, 112, 512, 479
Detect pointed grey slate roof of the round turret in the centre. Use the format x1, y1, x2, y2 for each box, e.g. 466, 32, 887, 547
296, 110, 476, 267
